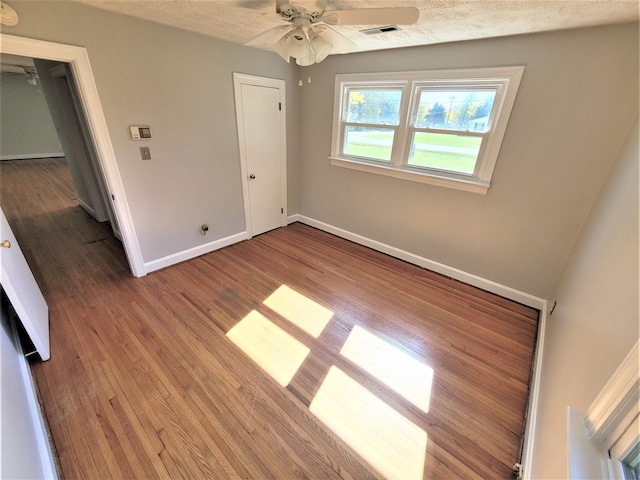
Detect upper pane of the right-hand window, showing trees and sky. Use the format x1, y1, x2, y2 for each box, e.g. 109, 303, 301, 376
416, 90, 496, 132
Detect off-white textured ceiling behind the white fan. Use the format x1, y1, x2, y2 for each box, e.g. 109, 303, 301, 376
60, 0, 640, 51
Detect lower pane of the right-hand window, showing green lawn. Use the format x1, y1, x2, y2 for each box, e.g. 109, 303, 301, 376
408, 132, 482, 175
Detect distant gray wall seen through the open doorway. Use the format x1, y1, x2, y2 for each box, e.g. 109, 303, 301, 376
0, 73, 63, 160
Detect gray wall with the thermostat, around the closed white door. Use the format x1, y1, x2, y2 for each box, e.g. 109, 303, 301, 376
8, 1, 298, 262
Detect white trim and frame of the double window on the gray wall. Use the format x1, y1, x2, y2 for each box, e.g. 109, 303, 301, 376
329, 66, 524, 194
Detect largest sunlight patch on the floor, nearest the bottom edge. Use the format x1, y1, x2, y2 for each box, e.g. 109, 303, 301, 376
309, 366, 427, 480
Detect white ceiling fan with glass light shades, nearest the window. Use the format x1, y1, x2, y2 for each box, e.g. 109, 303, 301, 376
247, 0, 420, 66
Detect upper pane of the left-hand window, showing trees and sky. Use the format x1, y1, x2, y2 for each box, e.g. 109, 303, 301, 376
347, 90, 402, 125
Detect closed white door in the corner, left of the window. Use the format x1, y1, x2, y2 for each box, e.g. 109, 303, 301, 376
235, 74, 286, 236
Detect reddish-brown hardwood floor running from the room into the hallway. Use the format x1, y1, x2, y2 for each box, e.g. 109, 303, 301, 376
0, 159, 538, 479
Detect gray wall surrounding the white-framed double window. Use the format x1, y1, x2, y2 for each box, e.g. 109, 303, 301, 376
299, 24, 638, 298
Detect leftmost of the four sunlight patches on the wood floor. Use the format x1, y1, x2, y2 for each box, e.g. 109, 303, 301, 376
227, 310, 310, 387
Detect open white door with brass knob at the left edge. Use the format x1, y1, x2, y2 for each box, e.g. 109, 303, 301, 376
0, 208, 50, 360
